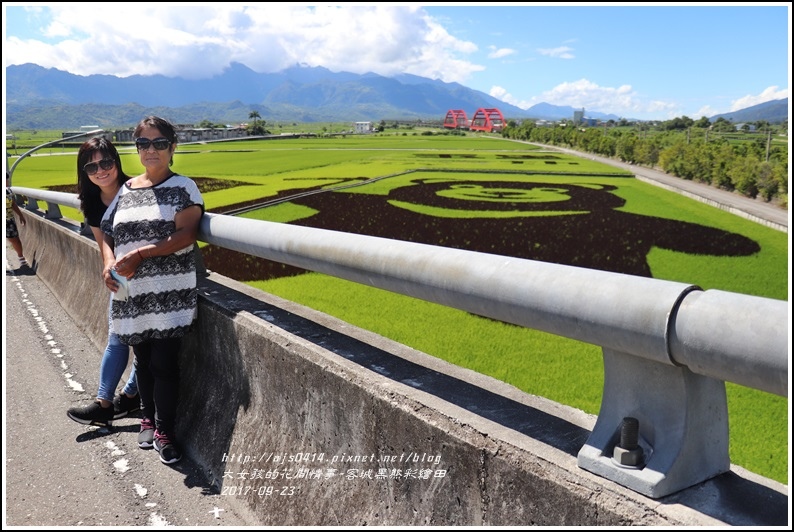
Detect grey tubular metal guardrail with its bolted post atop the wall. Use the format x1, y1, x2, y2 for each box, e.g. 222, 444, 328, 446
12, 187, 790, 498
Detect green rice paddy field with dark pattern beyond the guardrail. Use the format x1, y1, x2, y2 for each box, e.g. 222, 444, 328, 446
11, 135, 790, 483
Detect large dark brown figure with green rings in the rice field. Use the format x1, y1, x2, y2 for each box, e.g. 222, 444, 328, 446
203, 179, 760, 281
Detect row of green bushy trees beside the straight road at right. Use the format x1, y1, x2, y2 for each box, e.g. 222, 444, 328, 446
502, 117, 788, 208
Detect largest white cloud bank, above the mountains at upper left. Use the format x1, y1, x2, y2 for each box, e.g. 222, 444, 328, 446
4, 3, 484, 82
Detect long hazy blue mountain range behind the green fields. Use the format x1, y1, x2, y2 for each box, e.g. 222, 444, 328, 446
5, 63, 787, 130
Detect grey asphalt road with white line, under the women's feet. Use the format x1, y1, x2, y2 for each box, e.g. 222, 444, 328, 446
3, 254, 251, 529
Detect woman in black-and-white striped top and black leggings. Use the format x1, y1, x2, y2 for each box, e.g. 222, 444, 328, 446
101, 116, 204, 464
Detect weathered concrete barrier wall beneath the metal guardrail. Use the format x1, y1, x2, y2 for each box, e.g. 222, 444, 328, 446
21, 213, 788, 526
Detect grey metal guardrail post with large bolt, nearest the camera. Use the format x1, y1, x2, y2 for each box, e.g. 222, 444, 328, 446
578, 348, 730, 499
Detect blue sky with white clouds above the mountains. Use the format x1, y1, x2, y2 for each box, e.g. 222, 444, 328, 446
3, 2, 791, 120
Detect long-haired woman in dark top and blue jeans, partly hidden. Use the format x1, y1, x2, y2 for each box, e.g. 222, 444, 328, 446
66, 137, 140, 426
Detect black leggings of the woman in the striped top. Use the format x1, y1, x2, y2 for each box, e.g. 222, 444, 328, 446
132, 338, 182, 435
